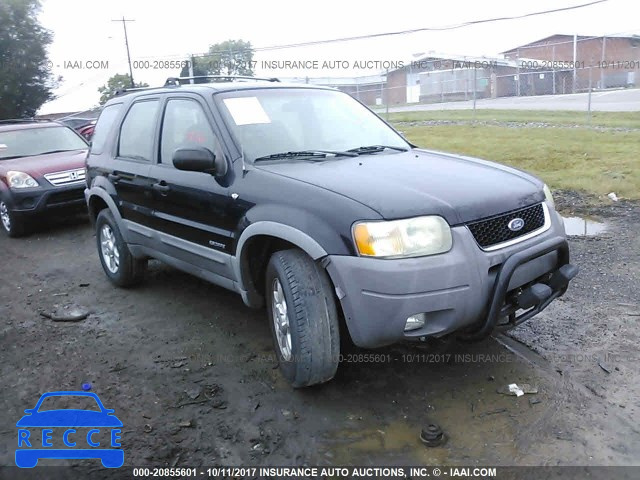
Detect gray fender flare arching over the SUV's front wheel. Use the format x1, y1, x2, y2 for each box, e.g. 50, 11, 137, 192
232, 221, 328, 308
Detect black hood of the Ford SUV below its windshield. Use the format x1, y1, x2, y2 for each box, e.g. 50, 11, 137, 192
255, 149, 544, 225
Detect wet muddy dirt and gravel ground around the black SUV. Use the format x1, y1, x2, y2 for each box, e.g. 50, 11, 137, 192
0, 192, 640, 467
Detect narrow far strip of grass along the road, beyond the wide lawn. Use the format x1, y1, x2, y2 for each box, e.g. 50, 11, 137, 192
388, 110, 640, 128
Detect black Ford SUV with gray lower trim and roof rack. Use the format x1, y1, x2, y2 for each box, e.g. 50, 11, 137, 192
85, 77, 577, 387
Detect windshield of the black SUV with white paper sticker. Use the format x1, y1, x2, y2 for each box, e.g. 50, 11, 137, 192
217, 88, 410, 161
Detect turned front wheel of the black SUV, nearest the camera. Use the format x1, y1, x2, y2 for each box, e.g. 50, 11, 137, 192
265, 250, 340, 388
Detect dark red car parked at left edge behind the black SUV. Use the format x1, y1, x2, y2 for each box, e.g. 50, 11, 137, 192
0, 120, 89, 237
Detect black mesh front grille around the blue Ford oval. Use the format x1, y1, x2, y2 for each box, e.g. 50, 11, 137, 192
467, 203, 545, 248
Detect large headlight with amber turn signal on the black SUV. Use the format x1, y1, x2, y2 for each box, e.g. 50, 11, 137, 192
353, 216, 452, 258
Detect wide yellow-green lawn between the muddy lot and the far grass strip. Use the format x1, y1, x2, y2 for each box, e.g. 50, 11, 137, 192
400, 124, 640, 199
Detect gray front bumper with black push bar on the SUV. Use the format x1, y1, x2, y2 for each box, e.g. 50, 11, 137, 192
325, 211, 577, 348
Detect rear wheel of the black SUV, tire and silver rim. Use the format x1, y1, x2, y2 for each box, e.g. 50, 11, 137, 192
96, 208, 147, 288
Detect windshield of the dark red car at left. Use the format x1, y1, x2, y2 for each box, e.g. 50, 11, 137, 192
0, 126, 88, 160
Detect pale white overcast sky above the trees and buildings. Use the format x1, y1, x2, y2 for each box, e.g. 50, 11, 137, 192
39, 0, 640, 114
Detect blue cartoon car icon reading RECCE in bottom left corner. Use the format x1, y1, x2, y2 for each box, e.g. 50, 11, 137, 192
16, 391, 124, 468
